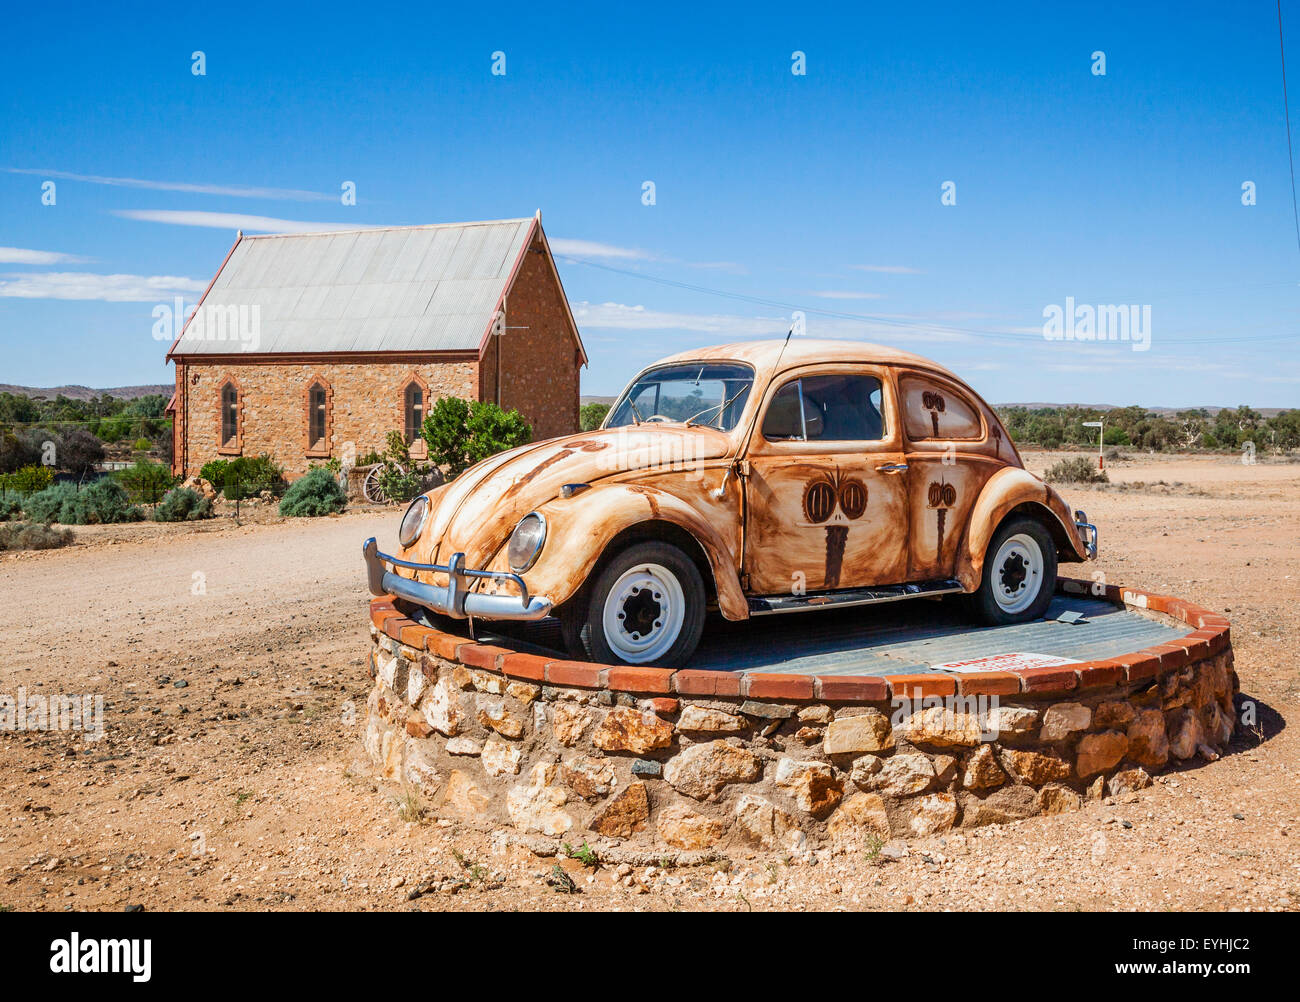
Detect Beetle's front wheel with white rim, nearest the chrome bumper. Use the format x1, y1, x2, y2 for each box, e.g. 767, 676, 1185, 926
563, 542, 706, 668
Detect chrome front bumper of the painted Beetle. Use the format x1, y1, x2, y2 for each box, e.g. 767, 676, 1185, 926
361, 537, 551, 620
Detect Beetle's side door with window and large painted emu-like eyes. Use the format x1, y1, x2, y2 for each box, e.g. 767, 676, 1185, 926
744, 364, 909, 595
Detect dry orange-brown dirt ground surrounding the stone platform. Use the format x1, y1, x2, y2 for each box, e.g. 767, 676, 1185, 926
0, 454, 1300, 910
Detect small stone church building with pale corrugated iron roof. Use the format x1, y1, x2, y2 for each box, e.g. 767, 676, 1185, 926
168, 212, 586, 477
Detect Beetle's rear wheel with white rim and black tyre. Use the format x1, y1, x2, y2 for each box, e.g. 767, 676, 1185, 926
971, 519, 1057, 626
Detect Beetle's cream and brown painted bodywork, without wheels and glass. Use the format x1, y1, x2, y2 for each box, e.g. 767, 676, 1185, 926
377, 338, 1095, 620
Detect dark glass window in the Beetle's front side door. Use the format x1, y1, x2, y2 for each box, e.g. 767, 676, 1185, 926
763, 373, 885, 442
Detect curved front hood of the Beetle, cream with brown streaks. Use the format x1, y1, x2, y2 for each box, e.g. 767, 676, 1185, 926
408, 424, 733, 567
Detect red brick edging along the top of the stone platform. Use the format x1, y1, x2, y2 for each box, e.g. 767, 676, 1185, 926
371, 578, 1231, 703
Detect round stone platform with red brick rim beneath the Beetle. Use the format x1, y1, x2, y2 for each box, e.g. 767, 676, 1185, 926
364, 580, 1238, 853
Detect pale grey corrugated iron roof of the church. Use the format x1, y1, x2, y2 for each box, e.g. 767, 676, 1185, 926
170, 218, 534, 355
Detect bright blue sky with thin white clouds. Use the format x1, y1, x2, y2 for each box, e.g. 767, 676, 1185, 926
0, 1, 1300, 407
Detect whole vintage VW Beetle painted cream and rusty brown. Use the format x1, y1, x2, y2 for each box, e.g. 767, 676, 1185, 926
364, 338, 1097, 667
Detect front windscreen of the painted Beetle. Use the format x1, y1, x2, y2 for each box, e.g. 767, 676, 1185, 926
605, 361, 754, 431
